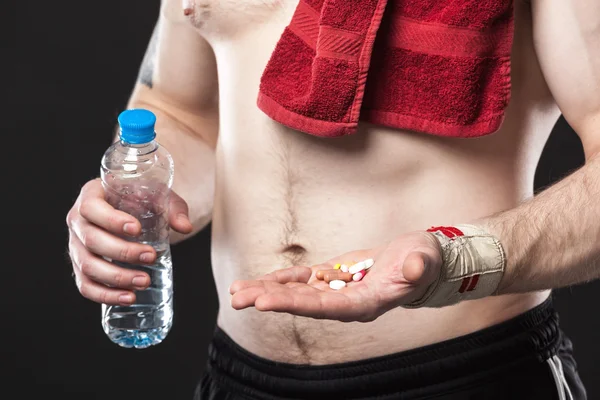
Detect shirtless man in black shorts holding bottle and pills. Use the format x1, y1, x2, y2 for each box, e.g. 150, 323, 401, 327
67, 0, 600, 399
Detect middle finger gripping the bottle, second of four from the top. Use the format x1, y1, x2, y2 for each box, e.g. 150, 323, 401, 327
72, 218, 156, 264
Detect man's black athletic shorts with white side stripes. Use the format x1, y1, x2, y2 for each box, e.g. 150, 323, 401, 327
195, 299, 586, 400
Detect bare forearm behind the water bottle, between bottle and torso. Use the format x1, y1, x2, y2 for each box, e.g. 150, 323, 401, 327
128, 95, 218, 243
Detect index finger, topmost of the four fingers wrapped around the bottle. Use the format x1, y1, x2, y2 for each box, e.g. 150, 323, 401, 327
79, 195, 142, 236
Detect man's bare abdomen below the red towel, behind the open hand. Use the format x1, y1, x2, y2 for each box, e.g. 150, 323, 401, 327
192, 0, 559, 365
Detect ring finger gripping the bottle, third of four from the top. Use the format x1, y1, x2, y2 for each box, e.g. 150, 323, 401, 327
69, 235, 150, 290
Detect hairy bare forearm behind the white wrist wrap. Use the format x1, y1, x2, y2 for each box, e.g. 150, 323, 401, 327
474, 156, 600, 294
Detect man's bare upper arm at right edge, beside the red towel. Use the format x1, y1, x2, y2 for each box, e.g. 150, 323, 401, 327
531, 0, 600, 157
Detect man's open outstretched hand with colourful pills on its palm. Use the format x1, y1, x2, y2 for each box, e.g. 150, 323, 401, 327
230, 232, 441, 322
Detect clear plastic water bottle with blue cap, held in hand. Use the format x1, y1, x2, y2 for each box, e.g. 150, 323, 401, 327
100, 109, 174, 348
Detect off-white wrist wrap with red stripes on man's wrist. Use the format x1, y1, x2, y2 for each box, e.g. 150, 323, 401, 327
403, 225, 506, 308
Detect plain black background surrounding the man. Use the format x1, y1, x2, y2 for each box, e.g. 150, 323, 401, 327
9, 0, 600, 400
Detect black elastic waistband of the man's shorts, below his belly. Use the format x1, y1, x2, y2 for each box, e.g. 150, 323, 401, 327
207, 298, 561, 399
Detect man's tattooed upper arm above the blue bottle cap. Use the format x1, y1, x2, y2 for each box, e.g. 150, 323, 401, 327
129, 0, 218, 142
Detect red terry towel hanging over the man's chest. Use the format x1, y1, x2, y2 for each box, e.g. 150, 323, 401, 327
258, 0, 514, 137
